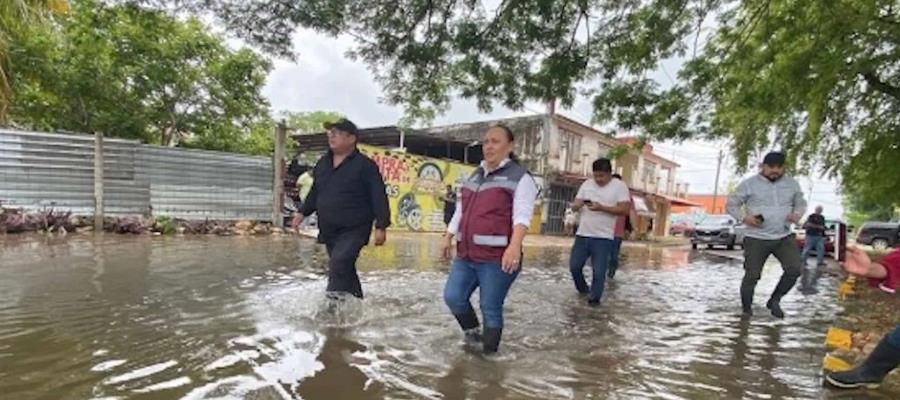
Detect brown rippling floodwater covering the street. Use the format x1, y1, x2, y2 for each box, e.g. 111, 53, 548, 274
0, 235, 891, 400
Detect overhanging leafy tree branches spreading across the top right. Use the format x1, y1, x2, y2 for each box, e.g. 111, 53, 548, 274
158, 0, 900, 204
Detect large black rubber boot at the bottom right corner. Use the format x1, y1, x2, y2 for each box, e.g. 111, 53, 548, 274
825, 337, 900, 389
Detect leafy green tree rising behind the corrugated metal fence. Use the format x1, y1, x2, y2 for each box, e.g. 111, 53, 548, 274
10, 0, 271, 151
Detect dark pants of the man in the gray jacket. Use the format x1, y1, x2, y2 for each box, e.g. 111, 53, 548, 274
741, 235, 803, 309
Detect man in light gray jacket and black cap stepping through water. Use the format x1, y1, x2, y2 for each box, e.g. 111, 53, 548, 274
726, 152, 806, 318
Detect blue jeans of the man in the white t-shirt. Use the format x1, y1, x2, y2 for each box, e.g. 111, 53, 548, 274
569, 236, 615, 301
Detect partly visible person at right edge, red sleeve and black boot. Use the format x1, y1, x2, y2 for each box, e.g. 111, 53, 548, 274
825, 247, 900, 389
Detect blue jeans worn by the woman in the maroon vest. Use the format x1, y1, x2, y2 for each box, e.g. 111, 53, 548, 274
444, 257, 522, 328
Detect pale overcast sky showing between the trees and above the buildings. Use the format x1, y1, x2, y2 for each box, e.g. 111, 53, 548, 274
264, 29, 843, 217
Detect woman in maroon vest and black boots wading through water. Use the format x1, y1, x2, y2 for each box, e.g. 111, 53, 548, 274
443, 125, 537, 354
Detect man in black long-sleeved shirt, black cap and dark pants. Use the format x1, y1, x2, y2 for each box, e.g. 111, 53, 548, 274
292, 119, 391, 298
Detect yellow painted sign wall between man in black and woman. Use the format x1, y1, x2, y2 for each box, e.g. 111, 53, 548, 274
359, 145, 475, 232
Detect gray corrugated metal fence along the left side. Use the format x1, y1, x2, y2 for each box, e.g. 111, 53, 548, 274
0, 129, 273, 220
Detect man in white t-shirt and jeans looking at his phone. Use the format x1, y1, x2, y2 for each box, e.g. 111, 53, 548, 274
569, 158, 631, 306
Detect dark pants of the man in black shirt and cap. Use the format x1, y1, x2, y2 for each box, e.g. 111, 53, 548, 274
325, 227, 371, 298
